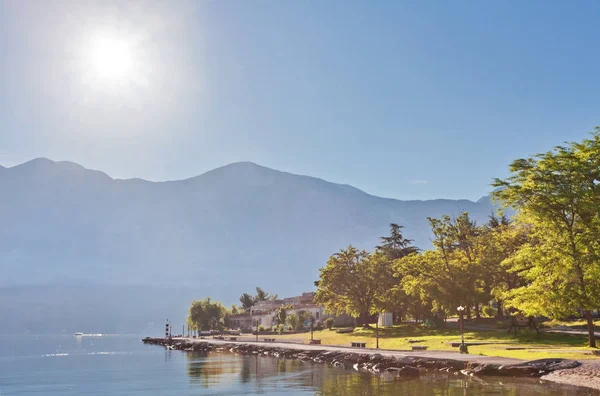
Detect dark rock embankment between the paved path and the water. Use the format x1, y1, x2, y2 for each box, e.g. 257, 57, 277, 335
142, 337, 580, 377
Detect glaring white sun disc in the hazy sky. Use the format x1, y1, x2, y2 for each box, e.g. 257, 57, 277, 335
89, 36, 134, 81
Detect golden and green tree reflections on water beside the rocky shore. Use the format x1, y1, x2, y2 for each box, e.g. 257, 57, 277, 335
186, 353, 600, 396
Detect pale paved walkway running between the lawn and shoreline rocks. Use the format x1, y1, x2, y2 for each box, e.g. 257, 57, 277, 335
174, 337, 525, 365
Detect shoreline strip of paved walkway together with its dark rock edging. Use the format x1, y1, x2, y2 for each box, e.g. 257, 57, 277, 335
142, 337, 584, 382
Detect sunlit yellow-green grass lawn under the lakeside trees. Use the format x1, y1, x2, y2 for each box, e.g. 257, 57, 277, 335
275, 324, 599, 360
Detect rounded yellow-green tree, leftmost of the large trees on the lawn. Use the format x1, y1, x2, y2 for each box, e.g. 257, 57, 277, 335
315, 246, 393, 325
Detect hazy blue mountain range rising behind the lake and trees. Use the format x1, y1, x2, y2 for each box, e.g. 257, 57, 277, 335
0, 159, 500, 332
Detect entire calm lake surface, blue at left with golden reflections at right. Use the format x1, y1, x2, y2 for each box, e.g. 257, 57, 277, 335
0, 335, 600, 396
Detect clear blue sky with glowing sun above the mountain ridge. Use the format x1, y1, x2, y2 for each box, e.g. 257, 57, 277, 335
0, 0, 600, 199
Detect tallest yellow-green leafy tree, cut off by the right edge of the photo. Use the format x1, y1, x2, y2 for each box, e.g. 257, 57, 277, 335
494, 128, 600, 347
